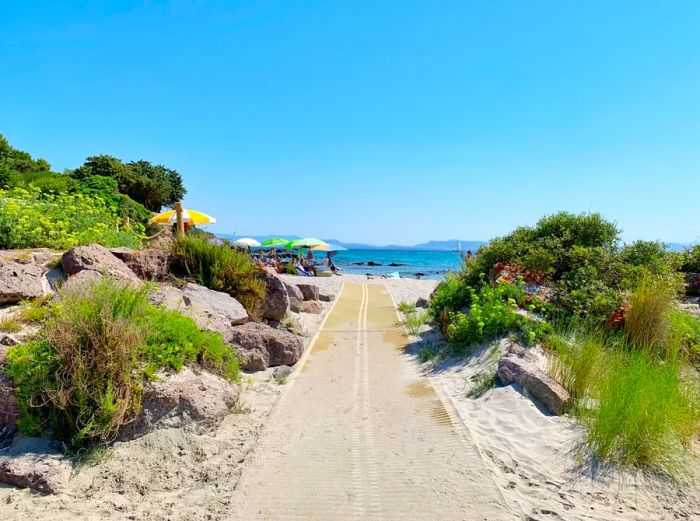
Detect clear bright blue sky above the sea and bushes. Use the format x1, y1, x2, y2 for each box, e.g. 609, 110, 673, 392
0, 0, 700, 244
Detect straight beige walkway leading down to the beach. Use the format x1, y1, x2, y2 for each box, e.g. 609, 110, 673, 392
235, 284, 520, 521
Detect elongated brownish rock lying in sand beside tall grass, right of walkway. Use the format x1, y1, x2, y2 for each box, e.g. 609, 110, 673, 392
498, 356, 571, 414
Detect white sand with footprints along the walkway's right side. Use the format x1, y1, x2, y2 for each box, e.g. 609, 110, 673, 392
427, 345, 700, 521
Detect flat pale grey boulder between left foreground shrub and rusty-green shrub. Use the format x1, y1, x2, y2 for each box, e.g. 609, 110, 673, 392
149, 283, 248, 333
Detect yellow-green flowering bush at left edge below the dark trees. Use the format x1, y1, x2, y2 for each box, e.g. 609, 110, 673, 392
0, 187, 143, 249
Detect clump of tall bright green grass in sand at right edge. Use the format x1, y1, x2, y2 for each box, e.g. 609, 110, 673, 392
584, 349, 700, 475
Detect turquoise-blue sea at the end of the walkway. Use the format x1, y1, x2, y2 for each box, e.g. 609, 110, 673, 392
328, 250, 461, 279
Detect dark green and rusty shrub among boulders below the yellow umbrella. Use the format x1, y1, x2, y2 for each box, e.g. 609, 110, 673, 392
173, 236, 265, 315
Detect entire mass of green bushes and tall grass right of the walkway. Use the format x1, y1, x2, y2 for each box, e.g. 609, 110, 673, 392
426, 213, 700, 475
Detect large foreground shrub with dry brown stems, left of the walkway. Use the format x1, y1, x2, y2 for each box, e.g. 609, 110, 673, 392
6, 278, 238, 450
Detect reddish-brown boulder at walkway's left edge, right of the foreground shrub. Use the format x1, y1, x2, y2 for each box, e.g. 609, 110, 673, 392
225, 322, 304, 370
